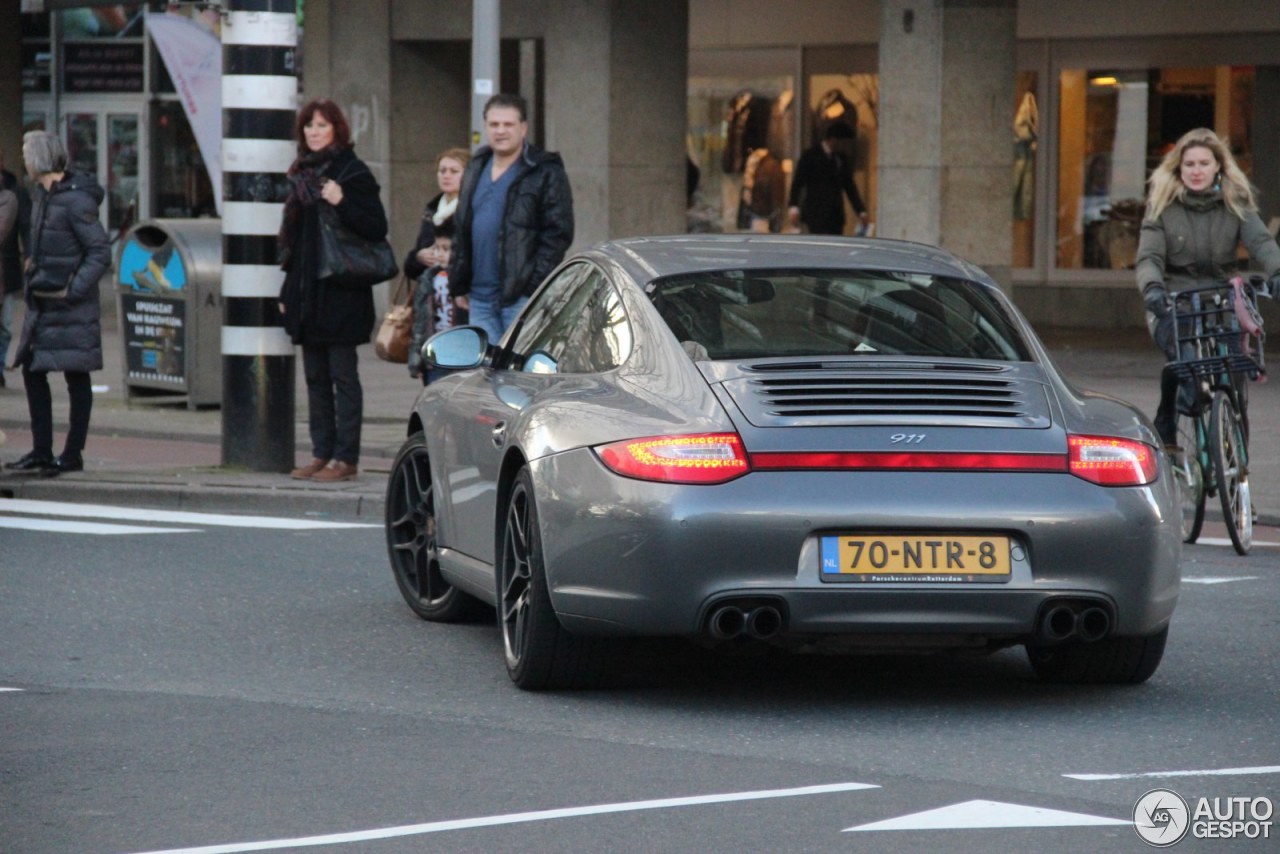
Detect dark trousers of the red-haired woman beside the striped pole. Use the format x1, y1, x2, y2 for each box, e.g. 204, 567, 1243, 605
302, 344, 365, 465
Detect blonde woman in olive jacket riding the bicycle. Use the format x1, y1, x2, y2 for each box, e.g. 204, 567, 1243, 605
1137, 128, 1280, 446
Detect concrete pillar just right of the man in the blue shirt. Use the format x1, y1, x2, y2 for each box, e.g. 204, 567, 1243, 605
544, 0, 689, 247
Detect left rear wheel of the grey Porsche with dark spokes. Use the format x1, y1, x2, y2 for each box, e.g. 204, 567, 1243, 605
497, 469, 605, 690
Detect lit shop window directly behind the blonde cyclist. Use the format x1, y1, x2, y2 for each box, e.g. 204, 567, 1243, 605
1056, 65, 1253, 270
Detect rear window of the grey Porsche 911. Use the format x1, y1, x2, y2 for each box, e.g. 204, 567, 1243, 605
645, 270, 1029, 361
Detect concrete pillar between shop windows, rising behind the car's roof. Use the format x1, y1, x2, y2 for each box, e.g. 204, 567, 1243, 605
877, 0, 1018, 289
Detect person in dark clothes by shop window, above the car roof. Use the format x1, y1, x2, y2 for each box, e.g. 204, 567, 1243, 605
787, 122, 869, 234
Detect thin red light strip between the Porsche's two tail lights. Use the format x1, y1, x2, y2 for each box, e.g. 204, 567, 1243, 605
751, 451, 1068, 471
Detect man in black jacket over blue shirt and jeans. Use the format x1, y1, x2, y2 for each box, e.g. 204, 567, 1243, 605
449, 93, 573, 342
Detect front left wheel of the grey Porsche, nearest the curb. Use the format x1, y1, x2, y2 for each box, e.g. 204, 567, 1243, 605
385, 433, 484, 622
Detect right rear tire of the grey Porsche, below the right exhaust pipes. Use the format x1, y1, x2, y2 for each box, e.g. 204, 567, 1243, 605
1027, 626, 1169, 685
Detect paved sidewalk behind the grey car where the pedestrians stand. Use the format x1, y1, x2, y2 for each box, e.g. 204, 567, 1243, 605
0, 316, 1280, 525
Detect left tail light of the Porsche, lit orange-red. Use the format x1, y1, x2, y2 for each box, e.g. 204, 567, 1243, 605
595, 433, 751, 484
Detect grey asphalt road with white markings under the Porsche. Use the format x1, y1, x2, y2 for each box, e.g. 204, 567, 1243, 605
0, 501, 1280, 854
